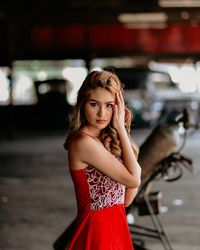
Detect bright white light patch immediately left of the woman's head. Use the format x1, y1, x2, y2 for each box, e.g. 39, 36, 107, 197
62, 67, 87, 105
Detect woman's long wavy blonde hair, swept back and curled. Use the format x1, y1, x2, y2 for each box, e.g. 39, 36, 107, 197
64, 71, 138, 159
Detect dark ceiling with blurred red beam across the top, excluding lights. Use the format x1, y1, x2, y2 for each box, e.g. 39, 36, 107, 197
0, 0, 200, 65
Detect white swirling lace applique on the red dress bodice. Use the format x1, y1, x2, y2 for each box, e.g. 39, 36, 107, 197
85, 167, 125, 210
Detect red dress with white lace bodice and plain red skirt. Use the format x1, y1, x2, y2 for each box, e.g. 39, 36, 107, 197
68, 166, 133, 250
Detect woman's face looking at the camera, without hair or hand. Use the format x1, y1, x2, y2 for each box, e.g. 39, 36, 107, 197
84, 87, 115, 130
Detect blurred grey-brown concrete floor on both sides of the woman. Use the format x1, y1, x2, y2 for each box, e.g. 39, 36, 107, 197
0, 130, 200, 250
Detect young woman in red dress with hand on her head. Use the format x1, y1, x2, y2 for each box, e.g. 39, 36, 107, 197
65, 71, 141, 250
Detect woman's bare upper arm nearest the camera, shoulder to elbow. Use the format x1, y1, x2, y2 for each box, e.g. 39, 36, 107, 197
68, 135, 140, 188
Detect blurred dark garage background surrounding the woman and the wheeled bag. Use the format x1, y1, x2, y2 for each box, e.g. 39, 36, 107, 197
0, 0, 200, 250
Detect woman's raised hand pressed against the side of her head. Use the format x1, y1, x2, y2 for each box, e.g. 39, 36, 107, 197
113, 91, 125, 132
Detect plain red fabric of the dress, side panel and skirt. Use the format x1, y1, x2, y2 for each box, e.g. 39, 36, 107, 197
68, 170, 133, 250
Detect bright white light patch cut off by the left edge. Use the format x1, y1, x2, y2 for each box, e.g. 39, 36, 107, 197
0, 68, 10, 105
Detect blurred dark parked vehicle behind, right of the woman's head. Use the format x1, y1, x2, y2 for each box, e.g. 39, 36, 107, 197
105, 67, 200, 127
